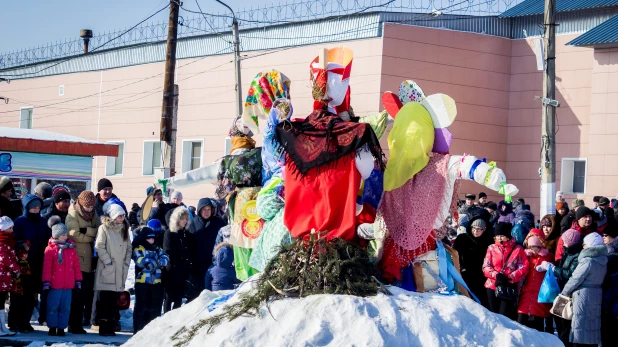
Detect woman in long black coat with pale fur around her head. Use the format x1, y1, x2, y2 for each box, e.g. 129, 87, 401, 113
163, 206, 190, 312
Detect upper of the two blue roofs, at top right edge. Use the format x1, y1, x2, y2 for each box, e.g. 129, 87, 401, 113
499, 0, 618, 18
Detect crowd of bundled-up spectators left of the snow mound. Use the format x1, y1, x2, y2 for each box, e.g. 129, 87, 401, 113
0, 177, 231, 336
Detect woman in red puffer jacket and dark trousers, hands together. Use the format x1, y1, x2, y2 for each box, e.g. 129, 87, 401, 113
483, 222, 528, 320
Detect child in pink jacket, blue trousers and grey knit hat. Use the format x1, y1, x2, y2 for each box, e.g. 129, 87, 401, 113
43, 216, 82, 336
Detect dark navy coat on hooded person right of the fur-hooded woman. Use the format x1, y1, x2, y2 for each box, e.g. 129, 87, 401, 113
189, 212, 227, 287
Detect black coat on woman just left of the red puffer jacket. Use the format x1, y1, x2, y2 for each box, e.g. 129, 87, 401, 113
453, 213, 493, 301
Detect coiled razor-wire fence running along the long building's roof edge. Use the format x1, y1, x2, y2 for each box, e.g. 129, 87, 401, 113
0, 0, 523, 70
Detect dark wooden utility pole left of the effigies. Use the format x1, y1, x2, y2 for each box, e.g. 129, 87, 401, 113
159, 0, 180, 178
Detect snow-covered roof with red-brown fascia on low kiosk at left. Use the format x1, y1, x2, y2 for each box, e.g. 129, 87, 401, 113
0, 127, 118, 157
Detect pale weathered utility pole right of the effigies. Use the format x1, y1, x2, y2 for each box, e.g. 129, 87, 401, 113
541, 0, 559, 216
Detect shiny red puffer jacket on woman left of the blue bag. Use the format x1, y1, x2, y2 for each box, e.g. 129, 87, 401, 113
483, 239, 528, 290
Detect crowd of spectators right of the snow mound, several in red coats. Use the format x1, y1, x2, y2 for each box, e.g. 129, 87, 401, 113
444, 192, 618, 346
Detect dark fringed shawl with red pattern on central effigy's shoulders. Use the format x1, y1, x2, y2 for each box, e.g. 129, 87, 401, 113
275, 109, 386, 176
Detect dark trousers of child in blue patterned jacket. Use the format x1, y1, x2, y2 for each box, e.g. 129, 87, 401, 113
133, 283, 163, 333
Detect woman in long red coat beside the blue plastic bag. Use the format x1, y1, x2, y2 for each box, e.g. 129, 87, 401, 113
517, 229, 554, 332
